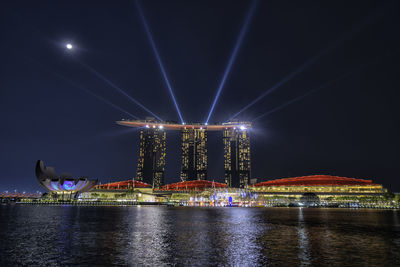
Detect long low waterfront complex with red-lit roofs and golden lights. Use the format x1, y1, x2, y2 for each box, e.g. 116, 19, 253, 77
74, 175, 388, 207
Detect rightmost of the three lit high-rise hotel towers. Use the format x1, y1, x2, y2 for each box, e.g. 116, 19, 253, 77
223, 126, 251, 188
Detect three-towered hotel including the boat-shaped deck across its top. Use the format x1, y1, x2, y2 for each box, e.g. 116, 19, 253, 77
117, 118, 252, 188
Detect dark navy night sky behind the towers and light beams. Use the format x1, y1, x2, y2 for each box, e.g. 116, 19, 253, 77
0, 0, 400, 192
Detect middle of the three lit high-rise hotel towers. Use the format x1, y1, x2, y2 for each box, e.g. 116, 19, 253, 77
181, 129, 207, 181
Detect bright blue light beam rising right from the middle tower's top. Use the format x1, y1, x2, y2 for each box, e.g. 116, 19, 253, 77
206, 0, 257, 123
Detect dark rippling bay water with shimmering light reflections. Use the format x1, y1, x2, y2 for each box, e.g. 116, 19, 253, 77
0, 205, 400, 266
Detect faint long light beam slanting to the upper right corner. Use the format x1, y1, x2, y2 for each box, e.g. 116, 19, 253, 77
229, 6, 383, 120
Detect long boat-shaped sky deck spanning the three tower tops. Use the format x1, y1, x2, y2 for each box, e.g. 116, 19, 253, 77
116, 120, 251, 131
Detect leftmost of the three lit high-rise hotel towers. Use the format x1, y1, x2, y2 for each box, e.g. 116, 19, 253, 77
136, 126, 167, 188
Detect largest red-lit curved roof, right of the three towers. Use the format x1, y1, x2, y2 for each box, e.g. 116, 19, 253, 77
254, 175, 376, 187
